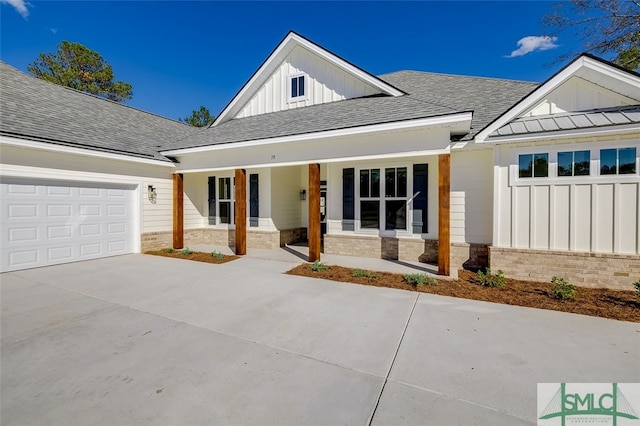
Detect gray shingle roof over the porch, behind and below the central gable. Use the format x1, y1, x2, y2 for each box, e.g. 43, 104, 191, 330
163, 71, 538, 150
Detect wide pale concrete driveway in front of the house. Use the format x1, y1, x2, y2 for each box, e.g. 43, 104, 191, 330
0, 255, 640, 425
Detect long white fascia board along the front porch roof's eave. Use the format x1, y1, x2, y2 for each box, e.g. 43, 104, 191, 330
161, 112, 473, 156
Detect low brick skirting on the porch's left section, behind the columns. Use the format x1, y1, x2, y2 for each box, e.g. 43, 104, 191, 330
141, 228, 307, 252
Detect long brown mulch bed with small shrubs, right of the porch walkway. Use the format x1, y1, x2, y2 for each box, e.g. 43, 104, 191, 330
287, 263, 640, 322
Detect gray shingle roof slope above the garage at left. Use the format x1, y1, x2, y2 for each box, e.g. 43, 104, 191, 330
0, 61, 198, 161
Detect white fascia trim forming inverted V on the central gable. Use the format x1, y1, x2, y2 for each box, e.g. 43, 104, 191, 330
210, 32, 404, 127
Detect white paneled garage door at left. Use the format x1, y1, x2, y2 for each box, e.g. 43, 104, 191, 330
0, 179, 136, 272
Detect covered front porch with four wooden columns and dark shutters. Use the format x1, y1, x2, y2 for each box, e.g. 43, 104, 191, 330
168, 153, 451, 276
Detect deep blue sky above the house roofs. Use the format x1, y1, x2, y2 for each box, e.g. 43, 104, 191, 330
0, 0, 577, 119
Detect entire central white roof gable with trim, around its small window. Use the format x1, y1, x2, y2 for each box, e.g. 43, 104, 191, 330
212, 31, 404, 127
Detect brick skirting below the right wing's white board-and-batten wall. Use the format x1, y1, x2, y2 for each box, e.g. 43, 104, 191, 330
489, 247, 640, 290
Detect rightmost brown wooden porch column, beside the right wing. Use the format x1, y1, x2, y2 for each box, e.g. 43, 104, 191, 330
438, 154, 451, 275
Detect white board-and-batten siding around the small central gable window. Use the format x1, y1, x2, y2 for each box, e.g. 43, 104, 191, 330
234, 46, 380, 118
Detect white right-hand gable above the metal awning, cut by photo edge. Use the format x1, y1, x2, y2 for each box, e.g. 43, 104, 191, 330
475, 54, 640, 143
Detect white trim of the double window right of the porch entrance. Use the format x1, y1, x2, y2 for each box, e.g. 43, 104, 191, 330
353, 163, 412, 237
